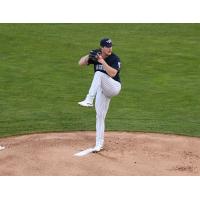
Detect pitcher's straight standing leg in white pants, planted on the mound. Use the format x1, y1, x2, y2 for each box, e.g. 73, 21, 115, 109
95, 88, 110, 151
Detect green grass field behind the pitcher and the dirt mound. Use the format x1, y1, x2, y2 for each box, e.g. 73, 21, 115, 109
0, 24, 200, 136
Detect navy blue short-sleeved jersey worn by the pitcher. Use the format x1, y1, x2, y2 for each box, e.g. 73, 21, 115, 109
88, 53, 121, 82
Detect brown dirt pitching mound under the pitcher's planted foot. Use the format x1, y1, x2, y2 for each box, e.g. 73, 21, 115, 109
0, 132, 200, 176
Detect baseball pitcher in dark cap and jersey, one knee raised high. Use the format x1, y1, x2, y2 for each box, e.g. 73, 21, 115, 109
78, 38, 121, 152
